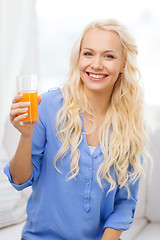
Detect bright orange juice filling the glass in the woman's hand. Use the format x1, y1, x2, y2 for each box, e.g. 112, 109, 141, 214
18, 91, 38, 125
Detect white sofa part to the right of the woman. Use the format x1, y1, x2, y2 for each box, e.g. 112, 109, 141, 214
122, 126, 160, 240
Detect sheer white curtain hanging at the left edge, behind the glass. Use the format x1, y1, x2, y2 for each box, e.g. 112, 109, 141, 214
0, 0, 37, 161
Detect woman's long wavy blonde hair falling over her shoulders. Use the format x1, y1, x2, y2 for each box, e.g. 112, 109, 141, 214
54, 20, 146, 191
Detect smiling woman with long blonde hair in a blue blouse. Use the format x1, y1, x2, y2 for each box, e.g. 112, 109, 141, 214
4, 20, 145, 240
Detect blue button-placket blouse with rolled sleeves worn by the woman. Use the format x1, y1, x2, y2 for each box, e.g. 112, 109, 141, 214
4, 89, 139, 240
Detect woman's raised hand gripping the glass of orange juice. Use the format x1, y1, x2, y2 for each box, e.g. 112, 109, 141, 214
10, 94, 42, 137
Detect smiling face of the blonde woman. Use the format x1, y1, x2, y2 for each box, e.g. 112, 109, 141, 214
79, 28, 124, 93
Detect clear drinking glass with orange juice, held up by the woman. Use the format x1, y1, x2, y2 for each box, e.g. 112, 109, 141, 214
17, 75, 39, 125
